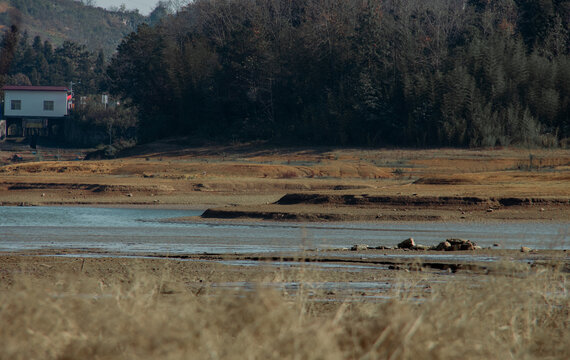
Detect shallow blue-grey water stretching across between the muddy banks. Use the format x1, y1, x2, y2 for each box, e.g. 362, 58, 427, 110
0, 207, 570, 254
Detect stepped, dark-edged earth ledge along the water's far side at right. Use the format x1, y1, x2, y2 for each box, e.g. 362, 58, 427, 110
202, 193, 570, 221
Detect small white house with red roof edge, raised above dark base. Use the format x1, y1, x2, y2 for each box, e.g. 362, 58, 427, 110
2, 86, 71, 137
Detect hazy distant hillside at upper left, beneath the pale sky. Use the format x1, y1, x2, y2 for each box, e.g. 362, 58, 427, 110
0, 0, 146, 56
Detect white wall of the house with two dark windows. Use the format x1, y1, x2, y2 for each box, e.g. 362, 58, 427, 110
4, 90, 67, 117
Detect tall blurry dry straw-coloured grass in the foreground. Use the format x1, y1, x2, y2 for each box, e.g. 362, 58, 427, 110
0, 260, 570, 359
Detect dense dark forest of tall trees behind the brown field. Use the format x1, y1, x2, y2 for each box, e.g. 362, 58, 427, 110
0, 0, 570, 147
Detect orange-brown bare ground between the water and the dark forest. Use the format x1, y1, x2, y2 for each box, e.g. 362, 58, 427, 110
0, 140, 570, 221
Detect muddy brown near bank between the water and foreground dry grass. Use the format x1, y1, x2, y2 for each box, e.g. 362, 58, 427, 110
0, 249, 570, 288
